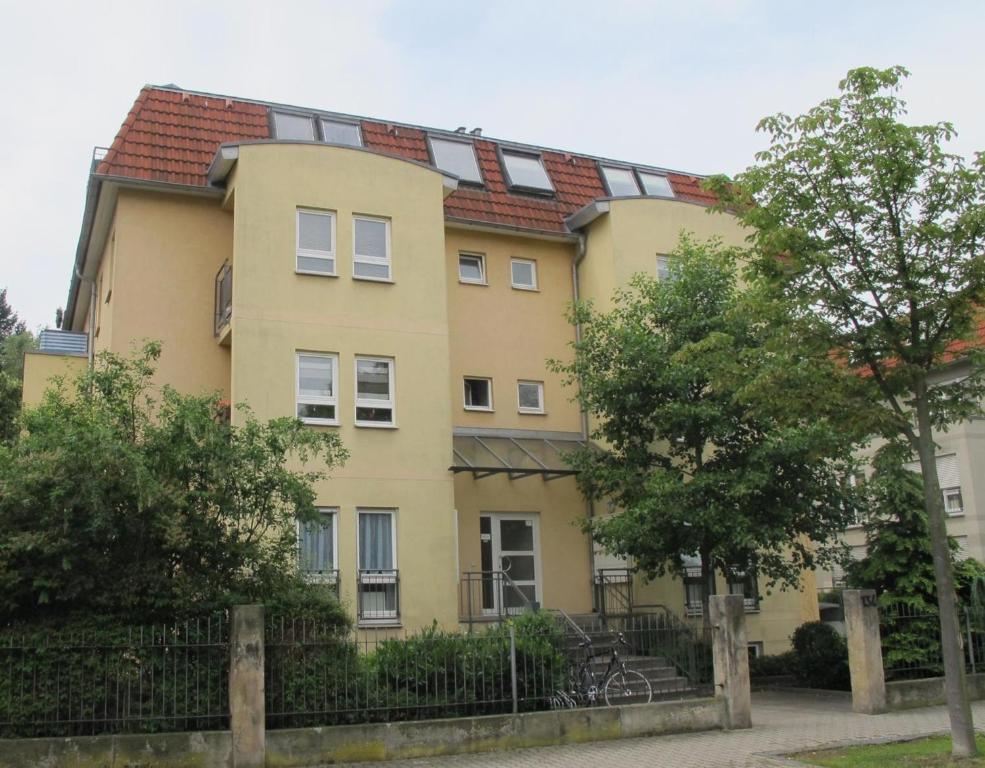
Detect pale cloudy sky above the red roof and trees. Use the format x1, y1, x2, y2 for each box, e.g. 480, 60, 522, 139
0, 0, 985, 328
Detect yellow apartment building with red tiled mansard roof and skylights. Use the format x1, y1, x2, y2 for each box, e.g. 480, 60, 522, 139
25, 86, 817, 652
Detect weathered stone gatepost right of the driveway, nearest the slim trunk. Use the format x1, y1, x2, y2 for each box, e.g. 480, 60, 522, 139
841, 589, 886, 715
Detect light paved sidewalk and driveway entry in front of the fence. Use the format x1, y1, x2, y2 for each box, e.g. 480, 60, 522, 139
332, 693, 985, 768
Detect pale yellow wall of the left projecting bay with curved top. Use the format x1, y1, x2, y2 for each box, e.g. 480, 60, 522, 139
231, 145, 457, 629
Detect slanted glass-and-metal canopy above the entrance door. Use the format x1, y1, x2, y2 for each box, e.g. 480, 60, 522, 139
449, 433, 584, 480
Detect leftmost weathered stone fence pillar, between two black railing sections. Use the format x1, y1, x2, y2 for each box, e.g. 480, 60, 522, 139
229, 605, 267, 768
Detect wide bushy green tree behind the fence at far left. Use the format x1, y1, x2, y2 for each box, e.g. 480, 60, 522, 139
0, 343, 347, 621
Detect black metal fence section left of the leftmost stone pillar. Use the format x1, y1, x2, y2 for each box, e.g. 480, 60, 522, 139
0, 614, 229, 738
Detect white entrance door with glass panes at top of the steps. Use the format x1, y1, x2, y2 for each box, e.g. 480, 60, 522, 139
481, 513, 541, 613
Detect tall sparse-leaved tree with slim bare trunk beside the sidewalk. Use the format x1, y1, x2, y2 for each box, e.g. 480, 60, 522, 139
711, 67, 985, 756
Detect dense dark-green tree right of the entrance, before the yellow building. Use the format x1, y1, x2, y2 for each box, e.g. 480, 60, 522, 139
551, 236, 852, 620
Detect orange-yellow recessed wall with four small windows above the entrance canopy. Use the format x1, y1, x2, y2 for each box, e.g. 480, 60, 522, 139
445, 229, 581, 432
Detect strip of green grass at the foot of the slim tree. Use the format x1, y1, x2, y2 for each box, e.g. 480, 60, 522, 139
791, 734, 985, 768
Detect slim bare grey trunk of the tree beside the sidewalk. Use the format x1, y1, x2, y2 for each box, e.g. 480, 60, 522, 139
915, 385, 978, 757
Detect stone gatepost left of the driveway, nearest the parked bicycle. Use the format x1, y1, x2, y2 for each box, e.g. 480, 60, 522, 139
708, 595, 752, 728
